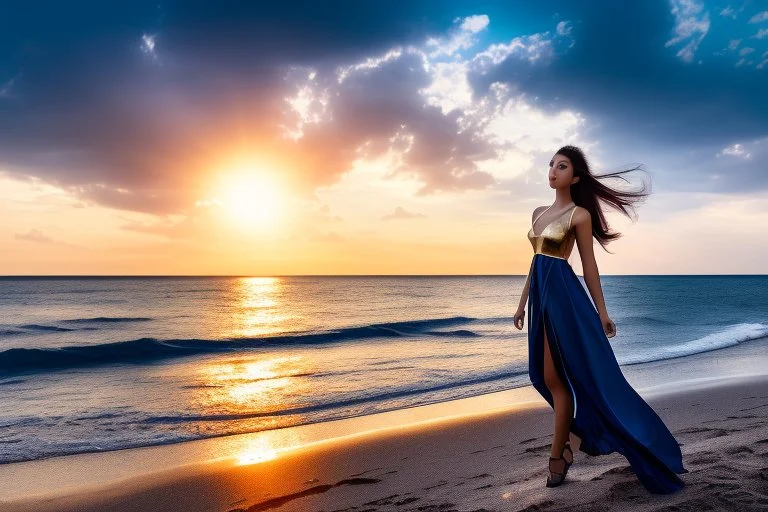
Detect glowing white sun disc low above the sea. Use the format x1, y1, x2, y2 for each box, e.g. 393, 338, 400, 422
218, 171, 281, 227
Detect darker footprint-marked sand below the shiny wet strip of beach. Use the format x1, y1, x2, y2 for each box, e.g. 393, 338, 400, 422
1, 375, 768, 512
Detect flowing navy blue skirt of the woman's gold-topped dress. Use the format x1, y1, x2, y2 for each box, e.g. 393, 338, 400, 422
528, 206, 688, 494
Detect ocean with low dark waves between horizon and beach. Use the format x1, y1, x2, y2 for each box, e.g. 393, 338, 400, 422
0, 275, 768, 463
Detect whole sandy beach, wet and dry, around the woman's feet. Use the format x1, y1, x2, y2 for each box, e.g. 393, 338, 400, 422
0, 336, 768, 512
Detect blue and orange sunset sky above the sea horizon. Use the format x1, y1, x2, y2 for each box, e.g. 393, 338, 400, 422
0, 0, 768, 276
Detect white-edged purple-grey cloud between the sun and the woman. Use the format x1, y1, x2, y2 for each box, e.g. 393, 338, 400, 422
284, 17, 570, 195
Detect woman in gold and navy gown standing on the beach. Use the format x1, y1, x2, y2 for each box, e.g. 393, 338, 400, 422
514, 146, 688, 494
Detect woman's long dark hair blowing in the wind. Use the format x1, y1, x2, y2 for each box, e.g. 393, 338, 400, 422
556, 146, 650, 252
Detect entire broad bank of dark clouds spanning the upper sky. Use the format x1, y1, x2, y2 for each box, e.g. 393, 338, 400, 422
0, 1, 765, 220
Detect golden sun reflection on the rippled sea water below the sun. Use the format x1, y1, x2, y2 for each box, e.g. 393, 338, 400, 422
185, 277, 315, 444
